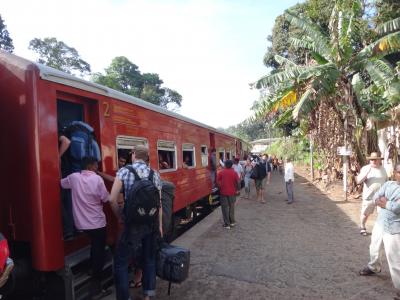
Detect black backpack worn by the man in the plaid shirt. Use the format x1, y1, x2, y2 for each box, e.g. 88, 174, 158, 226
123, 166, 160, 225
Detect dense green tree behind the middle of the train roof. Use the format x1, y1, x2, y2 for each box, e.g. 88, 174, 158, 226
92, 56, 182, 109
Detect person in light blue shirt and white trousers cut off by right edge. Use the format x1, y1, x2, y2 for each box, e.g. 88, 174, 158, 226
359, 164, 400, 300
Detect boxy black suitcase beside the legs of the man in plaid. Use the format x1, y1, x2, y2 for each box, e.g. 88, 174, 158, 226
157, 243, 190, 295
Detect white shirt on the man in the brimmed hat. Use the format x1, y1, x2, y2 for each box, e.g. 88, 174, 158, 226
357, 165, 387, 200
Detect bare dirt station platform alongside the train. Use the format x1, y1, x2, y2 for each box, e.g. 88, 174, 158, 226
109, 167, 395, 300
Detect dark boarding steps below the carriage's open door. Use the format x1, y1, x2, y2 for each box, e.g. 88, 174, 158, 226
63, 246, 113, 300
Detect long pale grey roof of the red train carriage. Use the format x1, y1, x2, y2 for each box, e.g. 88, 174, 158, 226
0, 50, 239, 139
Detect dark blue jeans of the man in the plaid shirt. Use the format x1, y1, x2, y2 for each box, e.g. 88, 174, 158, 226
114, 233, 156, 300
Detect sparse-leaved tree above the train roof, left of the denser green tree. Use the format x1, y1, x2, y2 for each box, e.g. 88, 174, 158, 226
29, 37, 90, 75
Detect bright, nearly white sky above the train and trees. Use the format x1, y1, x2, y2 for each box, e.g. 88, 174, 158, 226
0, 0, 301, 128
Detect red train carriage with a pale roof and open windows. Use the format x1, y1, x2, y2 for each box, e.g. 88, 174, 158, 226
0, 51, 244, 298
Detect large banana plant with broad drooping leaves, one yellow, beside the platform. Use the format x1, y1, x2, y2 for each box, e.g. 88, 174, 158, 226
254, 0, 400, 162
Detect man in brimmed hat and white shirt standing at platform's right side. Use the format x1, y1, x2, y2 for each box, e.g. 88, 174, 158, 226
357, 152, 387, 236
